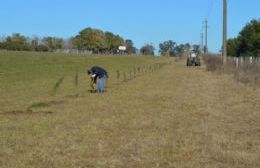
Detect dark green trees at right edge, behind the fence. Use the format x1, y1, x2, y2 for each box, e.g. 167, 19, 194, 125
227, 19, 260, 57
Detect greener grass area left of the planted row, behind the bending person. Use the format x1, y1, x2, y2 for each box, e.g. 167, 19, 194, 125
0, 51, 162, 111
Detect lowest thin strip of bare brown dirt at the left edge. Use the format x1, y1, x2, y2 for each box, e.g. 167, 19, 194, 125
0, 111, 53, 116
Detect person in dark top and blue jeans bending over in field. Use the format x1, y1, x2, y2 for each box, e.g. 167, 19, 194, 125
88, 66, 108, 93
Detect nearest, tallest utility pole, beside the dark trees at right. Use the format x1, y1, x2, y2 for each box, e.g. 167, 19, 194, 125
222, 0, 227, 64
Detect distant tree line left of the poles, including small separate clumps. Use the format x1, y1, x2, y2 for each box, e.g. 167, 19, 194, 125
0, 27, 199, 56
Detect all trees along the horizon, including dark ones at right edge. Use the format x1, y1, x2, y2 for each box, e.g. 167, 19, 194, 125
0, 19, 260, 57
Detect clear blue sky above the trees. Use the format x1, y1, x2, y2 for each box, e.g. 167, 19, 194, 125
0, 0, 260, 52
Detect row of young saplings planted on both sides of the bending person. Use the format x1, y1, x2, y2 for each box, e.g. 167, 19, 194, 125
51, 63, 170, 96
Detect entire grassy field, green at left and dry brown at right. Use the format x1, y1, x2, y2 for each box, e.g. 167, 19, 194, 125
0, 52, 260, 168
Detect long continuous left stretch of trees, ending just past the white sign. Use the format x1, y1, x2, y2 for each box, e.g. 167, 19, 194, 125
0, 28, 137, 54
